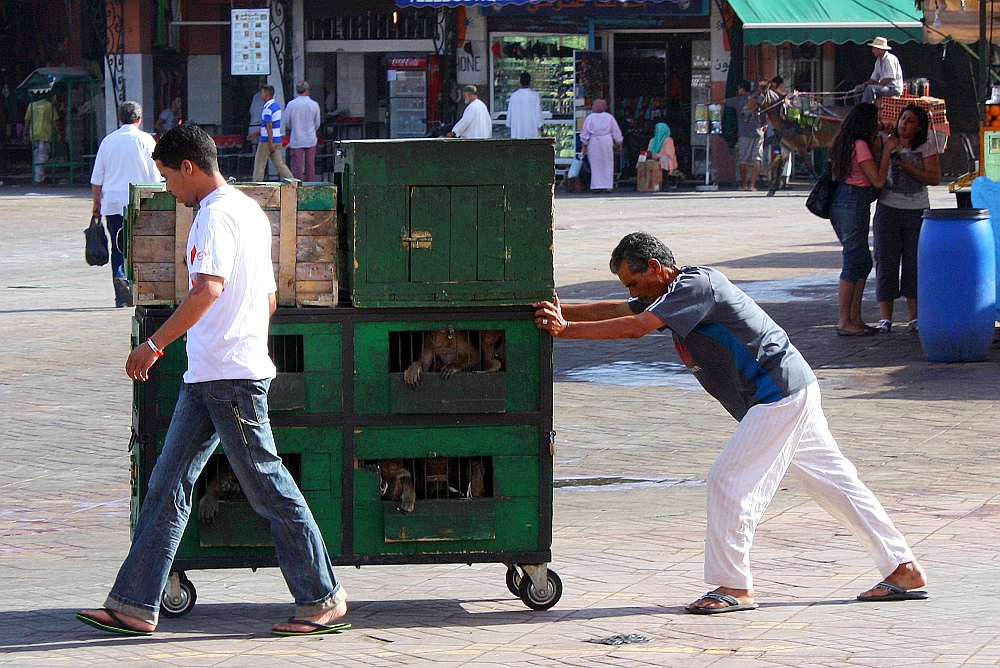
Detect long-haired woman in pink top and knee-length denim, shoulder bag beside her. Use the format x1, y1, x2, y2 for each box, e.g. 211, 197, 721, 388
830, 102, 887, 336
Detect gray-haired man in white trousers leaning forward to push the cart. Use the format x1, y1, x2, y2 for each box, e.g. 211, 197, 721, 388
535, 232, 927, 615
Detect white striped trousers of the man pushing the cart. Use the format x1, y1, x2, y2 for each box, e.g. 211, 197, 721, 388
705, 383, 914, 589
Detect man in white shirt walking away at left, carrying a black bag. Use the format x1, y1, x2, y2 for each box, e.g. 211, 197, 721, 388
90, 102, 160, 308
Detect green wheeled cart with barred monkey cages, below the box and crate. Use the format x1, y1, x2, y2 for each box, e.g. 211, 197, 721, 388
131, 306, 562, 616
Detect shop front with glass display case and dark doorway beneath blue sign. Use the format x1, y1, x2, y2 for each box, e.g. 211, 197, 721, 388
483, 0, 711, 178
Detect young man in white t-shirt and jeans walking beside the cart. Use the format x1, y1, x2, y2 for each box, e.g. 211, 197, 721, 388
77, 125, 350, 635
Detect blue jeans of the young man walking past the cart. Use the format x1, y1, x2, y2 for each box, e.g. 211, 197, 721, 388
104, 380, 346, 624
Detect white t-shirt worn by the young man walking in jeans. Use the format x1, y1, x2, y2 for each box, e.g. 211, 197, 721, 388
184, 185, 277, 383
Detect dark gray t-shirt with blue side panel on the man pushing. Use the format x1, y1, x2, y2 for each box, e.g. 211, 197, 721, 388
629, 267, 816, 420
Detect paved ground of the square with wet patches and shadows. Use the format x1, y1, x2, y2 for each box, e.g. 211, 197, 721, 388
0, 188, 1000, 667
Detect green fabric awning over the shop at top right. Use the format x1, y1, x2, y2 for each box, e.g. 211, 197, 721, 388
729, 0, 923, 44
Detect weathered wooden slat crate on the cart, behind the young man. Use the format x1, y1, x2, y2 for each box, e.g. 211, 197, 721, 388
125, 181, 338, 306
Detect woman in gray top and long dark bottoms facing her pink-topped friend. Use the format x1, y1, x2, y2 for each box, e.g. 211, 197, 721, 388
872, 104, 941, 332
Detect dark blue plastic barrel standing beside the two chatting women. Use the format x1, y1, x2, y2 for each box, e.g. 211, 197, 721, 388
917, 209, 996, 362
